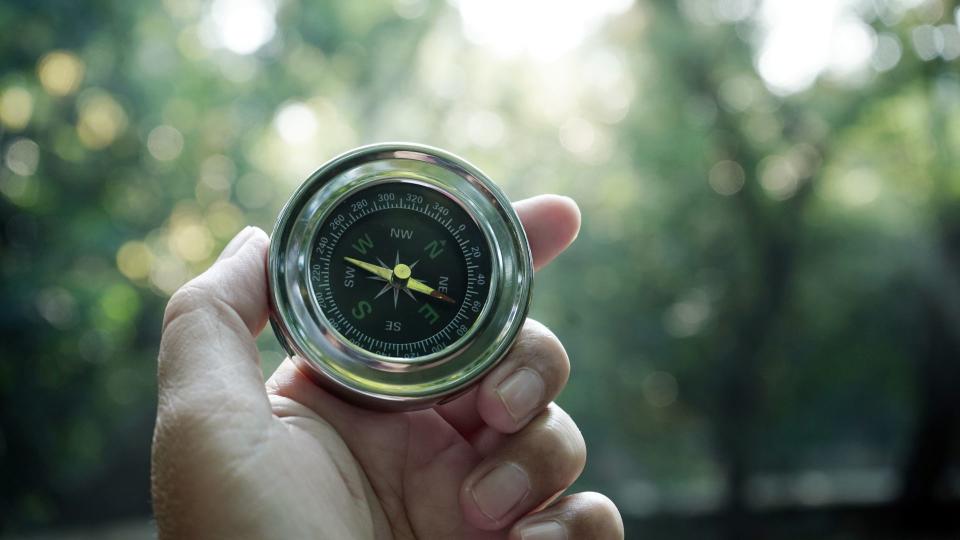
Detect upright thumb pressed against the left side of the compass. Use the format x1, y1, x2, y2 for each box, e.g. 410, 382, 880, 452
158, 227, 270, 420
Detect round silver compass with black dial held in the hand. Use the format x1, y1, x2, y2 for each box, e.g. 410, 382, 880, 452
268, 144, 533, 410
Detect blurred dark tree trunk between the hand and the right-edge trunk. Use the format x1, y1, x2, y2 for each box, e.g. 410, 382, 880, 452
648, 2, 812, 540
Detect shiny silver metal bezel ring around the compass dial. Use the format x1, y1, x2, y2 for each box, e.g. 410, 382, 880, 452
267, 143, 533, 410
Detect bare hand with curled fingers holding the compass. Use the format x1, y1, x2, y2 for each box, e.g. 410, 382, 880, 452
152, 196, 623, 540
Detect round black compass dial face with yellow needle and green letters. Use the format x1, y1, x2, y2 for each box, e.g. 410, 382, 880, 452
310, 182, 491, 358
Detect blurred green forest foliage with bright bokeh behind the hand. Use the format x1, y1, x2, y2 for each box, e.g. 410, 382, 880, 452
0, 0, 960, 530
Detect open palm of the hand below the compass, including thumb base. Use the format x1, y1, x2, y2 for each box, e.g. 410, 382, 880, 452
154, 340, 503, 539
